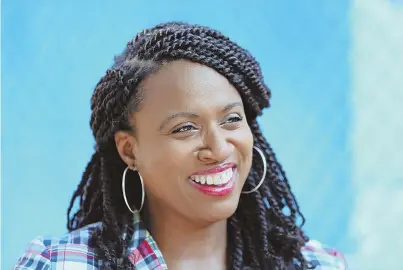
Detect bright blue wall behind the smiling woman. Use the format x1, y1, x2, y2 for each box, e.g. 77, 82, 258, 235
1, 0, 354, 269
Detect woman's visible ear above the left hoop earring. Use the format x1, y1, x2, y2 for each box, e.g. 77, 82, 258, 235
115, 131, 137, 168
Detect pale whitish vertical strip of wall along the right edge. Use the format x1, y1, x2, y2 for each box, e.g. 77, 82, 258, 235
347, 0, 403, 270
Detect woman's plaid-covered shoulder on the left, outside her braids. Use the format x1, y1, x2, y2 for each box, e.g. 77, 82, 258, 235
13, 223, 100, 270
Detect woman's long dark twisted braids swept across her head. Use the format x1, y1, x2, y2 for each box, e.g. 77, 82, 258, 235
68, 22, 308, 270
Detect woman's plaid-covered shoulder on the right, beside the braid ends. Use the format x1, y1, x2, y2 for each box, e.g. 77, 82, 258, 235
302, 240, 348, 270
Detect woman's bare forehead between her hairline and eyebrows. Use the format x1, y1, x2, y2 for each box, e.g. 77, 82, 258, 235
141, 60, 241, 109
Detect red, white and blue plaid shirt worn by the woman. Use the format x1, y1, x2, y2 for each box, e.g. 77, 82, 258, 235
13, 212, 348, 270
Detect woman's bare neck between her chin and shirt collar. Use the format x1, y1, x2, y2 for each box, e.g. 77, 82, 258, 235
149, 205, 227, 270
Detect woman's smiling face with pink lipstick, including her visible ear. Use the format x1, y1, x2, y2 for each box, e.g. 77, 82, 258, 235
116, 60, 253, 223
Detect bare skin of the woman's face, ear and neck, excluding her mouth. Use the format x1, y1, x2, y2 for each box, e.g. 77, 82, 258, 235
115, 60, 253, 270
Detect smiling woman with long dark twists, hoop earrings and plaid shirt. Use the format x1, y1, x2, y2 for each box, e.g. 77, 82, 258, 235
15, 22, 346, 270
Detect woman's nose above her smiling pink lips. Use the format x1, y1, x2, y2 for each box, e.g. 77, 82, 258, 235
198, 129, 233, 164
